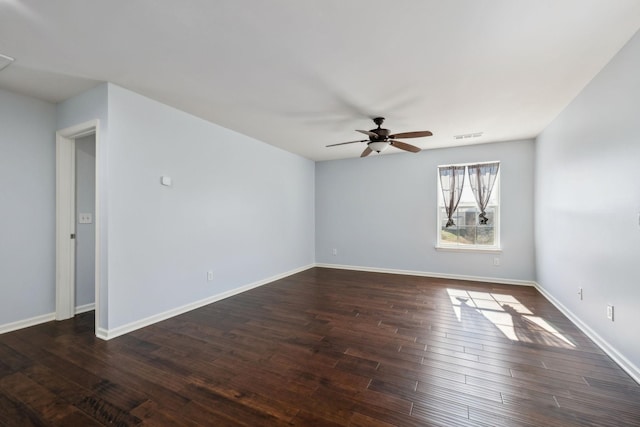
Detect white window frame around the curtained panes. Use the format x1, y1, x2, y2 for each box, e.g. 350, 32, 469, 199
435, 160, 502, 253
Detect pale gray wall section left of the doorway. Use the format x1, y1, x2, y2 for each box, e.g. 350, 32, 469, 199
0, 89, 55, 325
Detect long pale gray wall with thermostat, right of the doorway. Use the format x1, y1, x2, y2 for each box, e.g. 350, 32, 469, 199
107, 85, 314, 328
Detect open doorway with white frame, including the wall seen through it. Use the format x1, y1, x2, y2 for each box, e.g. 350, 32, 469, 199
56, 120, 100, 331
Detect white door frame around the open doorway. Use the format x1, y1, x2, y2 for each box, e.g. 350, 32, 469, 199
56, 119, 101, 331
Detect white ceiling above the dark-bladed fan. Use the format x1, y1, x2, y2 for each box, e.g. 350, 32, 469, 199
0, 0, 640, 160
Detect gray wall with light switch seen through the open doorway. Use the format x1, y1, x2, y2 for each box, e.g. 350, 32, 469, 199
75, 135, 96, 307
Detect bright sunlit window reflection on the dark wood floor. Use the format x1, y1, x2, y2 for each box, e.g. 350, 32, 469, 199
447, 289, 575, 348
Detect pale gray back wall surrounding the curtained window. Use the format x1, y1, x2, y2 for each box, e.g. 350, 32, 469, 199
316, 140, 535, 281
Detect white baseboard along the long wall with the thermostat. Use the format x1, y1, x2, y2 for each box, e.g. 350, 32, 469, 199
96, 264, 314, 340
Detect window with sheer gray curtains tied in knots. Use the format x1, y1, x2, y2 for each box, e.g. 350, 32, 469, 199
436, 162, 500, 250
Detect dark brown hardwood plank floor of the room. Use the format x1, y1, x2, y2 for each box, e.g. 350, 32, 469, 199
0, 268, 640, 427
